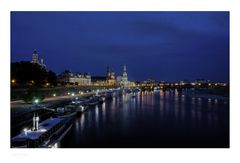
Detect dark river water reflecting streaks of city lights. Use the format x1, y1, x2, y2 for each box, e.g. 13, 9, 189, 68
57, 91, 229, 148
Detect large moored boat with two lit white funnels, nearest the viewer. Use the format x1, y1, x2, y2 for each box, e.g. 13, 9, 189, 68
11, 115, 73, 148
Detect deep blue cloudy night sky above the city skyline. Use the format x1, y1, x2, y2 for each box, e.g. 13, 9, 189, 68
11, 12, 229, 81
